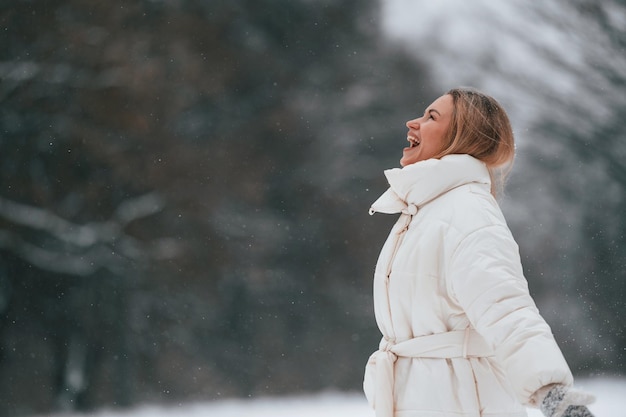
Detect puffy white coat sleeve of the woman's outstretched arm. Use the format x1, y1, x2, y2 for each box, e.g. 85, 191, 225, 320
448, 225, 573, 404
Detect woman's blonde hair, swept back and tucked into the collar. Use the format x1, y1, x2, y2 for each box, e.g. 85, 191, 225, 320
435, 88, 515, 196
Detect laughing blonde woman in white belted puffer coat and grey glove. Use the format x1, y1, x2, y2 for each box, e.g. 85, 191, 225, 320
364, 88, 593, 417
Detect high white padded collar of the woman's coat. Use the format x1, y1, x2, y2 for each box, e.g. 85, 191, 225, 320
369, 155, 491, 214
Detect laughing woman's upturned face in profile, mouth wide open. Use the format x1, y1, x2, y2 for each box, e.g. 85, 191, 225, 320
400, 94, 453, 167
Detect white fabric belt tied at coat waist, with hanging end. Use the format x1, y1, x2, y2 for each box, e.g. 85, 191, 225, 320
363, 328, 494, 417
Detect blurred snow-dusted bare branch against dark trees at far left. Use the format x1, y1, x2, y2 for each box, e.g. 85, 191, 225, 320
0, 193, 173, 276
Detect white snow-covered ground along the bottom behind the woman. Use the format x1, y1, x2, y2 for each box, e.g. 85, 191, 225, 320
37, 378, 626, 417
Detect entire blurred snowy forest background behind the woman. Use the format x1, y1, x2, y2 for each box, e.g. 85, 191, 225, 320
0, 0, 626, 416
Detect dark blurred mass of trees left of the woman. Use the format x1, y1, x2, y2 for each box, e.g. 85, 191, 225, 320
0, 0, 433, 415
